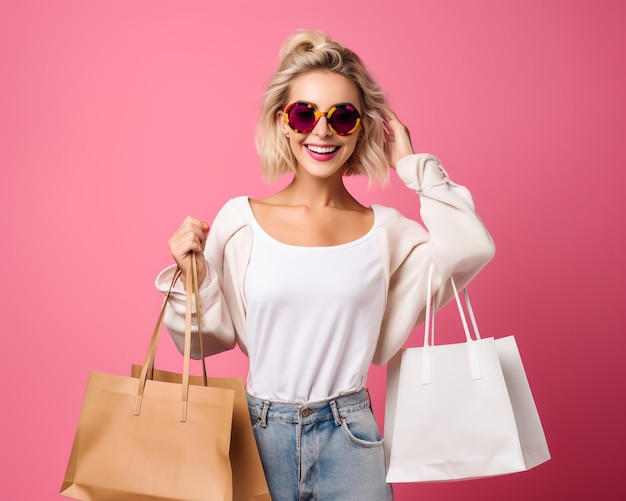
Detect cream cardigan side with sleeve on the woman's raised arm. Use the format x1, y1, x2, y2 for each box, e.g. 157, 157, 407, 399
374, 154, 495, 365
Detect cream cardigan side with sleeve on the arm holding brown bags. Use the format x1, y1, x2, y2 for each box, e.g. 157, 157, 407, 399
156, 199, 243, 359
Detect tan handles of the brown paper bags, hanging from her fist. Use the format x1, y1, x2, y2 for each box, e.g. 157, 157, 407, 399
133, 252, 207, 422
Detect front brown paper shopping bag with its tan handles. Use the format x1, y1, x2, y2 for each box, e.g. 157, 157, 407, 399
61, 259, 235, 501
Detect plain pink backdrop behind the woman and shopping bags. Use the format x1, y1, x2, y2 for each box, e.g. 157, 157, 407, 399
0, 0, 626, 501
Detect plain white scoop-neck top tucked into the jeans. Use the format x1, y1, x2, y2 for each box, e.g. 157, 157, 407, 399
236, 197, 385, 402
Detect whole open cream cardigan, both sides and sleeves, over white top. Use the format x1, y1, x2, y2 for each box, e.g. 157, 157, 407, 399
156, 154, 495, 365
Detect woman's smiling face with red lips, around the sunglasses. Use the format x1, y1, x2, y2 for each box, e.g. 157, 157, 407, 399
276, 71, 362, 178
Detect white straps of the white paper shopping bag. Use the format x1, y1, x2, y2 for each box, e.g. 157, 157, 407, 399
422, 264, 482, 384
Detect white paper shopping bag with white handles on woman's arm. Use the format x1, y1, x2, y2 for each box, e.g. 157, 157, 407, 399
385, 272, 550, 482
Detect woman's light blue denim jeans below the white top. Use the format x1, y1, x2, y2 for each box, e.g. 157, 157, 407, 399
248, 390, 393, 501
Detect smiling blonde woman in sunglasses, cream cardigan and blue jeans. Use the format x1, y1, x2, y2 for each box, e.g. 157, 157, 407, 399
157, 31, 494, 501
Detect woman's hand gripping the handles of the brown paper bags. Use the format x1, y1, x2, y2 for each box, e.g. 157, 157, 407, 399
168, 216, 209, 284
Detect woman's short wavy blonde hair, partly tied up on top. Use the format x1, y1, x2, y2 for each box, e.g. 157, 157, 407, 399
257, 30, 389, 184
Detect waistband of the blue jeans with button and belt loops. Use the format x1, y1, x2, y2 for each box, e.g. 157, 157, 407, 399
247, 388, 370, 427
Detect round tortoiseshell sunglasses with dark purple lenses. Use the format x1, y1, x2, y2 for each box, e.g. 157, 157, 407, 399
285, 102, 361, 136
